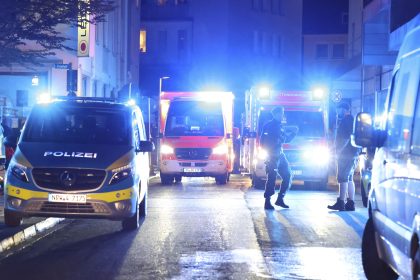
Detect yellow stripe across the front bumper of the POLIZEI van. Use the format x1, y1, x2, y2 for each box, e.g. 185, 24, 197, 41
6, 186, 134, 202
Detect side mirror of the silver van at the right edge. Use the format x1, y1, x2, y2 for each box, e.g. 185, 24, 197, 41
351, 112, 376, 147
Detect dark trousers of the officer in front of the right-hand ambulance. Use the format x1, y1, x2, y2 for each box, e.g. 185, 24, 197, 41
264, 153, 293, 198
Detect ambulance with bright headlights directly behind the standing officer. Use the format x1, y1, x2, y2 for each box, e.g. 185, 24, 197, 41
241, 90, 330, 189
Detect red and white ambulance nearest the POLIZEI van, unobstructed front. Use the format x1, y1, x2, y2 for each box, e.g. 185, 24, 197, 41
159, 92, 234, 184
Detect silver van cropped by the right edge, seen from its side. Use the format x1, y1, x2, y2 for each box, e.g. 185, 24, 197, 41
353, 26, 420, 280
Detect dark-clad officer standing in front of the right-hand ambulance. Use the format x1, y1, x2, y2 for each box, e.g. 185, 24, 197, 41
260, 107, 298, 210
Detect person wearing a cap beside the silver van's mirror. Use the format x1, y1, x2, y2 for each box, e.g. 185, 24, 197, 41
328, 102, 360, 211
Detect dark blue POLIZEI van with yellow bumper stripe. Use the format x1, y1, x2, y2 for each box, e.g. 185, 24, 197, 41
4, 97, 154, 230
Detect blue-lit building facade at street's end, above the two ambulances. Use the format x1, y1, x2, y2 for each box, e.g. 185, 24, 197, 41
140, 0, 302, 98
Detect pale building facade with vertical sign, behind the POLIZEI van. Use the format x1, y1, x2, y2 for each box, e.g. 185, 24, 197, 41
0, 0, 140, 127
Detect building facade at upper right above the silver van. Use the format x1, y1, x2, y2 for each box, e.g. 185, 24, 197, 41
334, 0, 420, 116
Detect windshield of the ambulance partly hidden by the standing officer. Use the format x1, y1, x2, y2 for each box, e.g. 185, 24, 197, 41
258, 110, 325, 138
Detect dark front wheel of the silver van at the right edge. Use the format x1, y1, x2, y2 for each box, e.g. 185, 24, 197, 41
362, 218, 398, 280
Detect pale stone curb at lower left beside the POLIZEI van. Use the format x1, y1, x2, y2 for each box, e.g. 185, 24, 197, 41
0, 218, 64, 254
